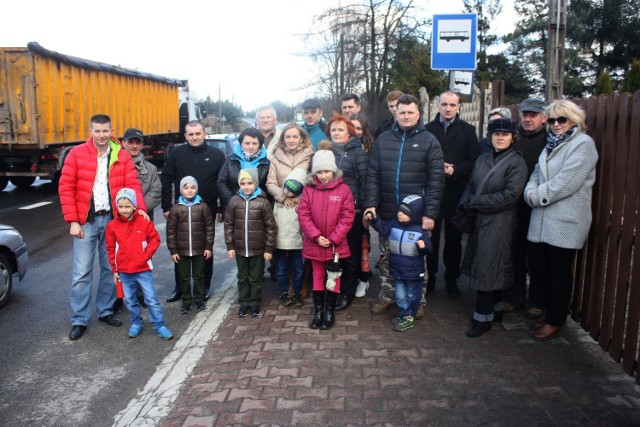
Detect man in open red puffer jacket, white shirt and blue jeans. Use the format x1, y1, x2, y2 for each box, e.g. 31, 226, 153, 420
58, 114, 148, 340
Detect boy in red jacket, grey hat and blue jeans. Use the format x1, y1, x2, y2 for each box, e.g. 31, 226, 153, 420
105, 188, 173, 340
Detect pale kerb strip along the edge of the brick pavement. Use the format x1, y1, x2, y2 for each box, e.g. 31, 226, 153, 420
113, 270, 238, 427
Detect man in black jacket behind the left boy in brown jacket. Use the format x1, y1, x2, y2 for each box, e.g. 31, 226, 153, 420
160, 120, 225, 302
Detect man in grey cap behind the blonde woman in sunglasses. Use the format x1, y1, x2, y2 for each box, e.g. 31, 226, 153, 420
502, 98, 547, 319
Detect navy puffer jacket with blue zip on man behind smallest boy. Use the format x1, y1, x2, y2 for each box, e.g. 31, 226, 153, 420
365, 122, 444, 220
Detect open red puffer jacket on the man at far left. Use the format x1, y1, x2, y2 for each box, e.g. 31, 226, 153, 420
58, 138, 147, 225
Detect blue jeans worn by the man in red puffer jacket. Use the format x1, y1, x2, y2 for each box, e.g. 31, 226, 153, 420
70, 215, 116, 326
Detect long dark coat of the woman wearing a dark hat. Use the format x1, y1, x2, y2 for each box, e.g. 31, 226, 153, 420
460, 148, 527, 292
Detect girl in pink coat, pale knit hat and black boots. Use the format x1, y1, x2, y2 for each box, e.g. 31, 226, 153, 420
298, 141, 355, 329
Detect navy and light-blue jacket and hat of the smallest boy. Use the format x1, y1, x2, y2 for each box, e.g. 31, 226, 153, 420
372, 195, 431, 280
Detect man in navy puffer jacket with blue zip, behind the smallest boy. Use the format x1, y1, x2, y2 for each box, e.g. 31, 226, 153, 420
365, 94, 444, 318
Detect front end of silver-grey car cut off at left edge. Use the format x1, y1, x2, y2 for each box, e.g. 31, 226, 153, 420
0, 224, 29, 308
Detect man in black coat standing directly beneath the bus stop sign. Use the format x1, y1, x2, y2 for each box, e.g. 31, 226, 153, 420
425, 91, 480, 298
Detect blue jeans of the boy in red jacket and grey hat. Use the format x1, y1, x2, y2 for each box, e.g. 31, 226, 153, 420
120, 270, 164, 329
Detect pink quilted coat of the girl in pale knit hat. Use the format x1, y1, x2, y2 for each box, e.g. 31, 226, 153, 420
298, 176, 355, 261
